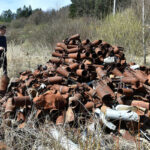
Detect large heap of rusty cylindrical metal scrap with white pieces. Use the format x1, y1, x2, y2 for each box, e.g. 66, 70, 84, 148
0, 34, 150, 141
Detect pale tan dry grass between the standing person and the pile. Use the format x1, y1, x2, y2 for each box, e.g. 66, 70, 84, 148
3, 42, 52, 77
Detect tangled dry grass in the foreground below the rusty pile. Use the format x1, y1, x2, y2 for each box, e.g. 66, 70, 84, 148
0, 110, 150, 150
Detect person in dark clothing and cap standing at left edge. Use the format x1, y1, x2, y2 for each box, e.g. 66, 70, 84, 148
0, 25, 7, 75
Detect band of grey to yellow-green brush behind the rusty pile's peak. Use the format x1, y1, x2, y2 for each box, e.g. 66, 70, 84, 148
8, 9, 150, 56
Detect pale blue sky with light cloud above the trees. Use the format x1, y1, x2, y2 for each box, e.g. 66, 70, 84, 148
0, 0, 71, 13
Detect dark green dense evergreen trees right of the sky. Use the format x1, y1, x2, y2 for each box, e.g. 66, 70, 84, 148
70, 0, 133, 18
